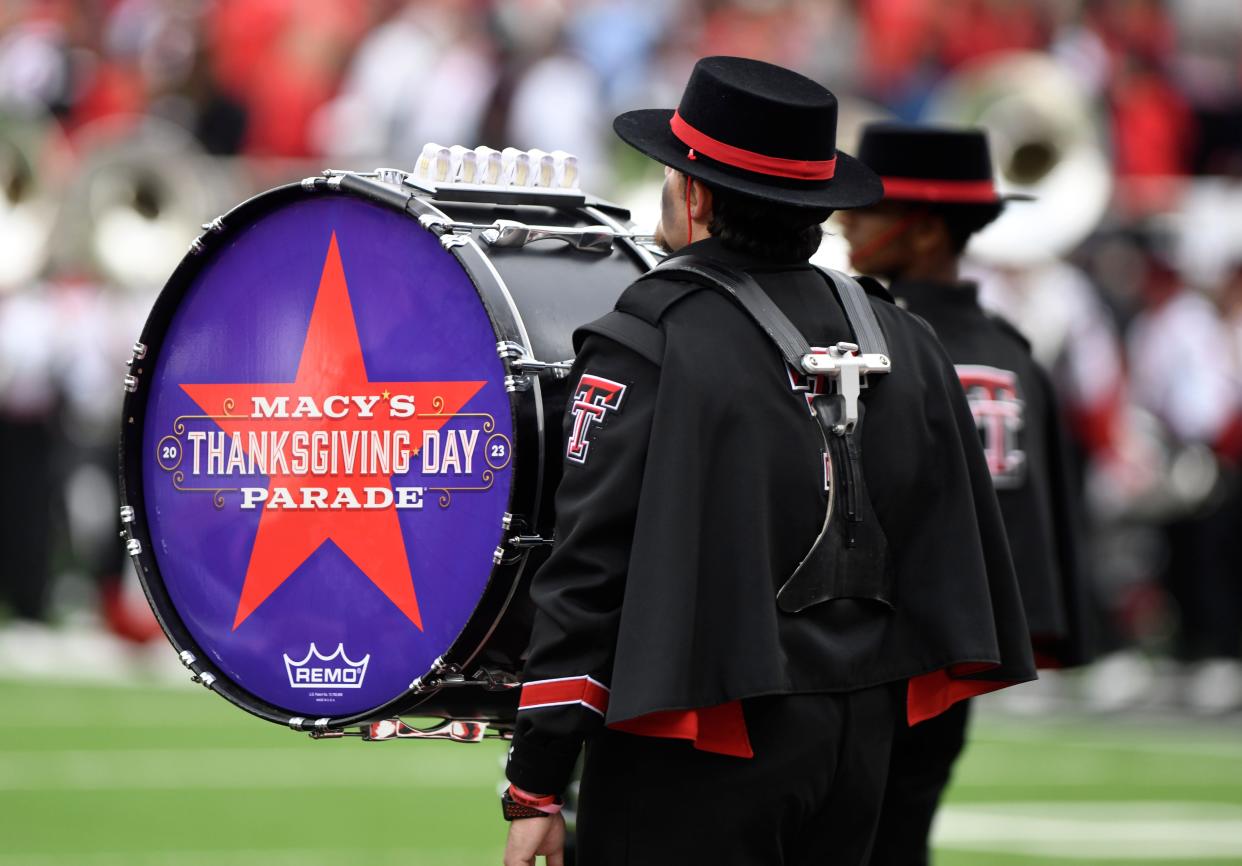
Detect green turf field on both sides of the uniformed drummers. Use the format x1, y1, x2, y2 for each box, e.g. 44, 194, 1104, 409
0, 680, 1242, 866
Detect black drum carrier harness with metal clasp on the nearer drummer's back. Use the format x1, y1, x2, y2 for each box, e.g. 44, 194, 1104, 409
574, 255, 893, 614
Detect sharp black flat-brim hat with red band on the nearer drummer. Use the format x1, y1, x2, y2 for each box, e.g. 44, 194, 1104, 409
612, 57, 883, 210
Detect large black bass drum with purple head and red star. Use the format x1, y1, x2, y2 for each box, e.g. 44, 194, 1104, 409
122, 167, 655, 732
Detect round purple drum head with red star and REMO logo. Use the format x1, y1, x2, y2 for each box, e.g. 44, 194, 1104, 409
142, 195, 513, 717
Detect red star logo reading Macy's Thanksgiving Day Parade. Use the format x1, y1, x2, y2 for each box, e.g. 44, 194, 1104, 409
155, 235, 512, 629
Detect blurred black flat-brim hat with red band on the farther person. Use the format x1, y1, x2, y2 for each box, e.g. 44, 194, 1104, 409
858, 123, 1032, 206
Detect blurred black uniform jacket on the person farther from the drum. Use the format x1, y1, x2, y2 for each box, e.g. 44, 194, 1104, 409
892, 282, 1092, 667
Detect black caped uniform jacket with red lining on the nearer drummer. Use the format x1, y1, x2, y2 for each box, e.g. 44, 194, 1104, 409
508, 239, 1035, 793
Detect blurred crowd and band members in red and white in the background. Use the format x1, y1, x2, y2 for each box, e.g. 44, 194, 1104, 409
0, 0, 1242, 712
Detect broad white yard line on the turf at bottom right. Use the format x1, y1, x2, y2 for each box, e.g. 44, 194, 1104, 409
933, 801, 1242, 862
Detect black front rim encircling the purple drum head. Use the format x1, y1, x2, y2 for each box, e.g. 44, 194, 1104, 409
118, 175, 545, 729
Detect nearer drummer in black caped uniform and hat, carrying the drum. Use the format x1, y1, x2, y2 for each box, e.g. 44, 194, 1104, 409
502, 57, 1033, 866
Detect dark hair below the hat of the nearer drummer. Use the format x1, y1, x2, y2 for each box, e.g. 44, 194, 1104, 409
707, 186, 832, 261
